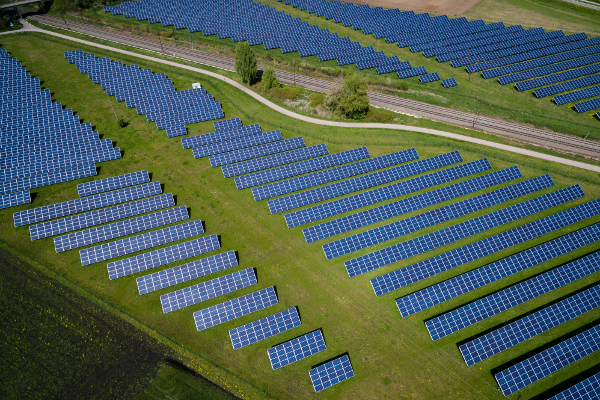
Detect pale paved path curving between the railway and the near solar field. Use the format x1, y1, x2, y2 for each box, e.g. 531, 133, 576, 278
8, 21, 600, 172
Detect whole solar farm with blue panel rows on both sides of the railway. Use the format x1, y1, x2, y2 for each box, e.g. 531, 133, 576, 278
0, 0, 600, 399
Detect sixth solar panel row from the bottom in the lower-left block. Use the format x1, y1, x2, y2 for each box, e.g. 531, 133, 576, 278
136, 250, 238, 294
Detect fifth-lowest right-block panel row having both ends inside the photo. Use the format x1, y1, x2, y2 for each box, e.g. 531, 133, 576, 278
268, 152, 462, 214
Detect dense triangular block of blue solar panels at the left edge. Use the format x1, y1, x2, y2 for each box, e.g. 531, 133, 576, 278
0, 48, 121, 198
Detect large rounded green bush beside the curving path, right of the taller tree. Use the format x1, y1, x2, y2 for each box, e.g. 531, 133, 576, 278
323, 75, 369, 119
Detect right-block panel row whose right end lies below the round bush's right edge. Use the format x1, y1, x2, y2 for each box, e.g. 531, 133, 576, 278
235, 147, 370, 189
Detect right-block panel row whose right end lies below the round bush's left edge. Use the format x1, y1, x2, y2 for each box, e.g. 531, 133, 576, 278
221, 143, 329, 179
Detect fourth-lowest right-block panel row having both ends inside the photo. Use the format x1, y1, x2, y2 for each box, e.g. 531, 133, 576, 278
285, 158, 494, 228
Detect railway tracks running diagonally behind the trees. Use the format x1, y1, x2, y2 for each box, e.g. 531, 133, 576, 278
24, 15, 600, 159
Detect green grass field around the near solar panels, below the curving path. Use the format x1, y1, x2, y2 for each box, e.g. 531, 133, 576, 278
0, 34, 600, 399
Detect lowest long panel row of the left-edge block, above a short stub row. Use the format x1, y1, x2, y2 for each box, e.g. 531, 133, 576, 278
0, 164, 97, 195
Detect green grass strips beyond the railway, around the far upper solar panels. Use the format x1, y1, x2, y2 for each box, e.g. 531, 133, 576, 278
41, 0, 600, 140
